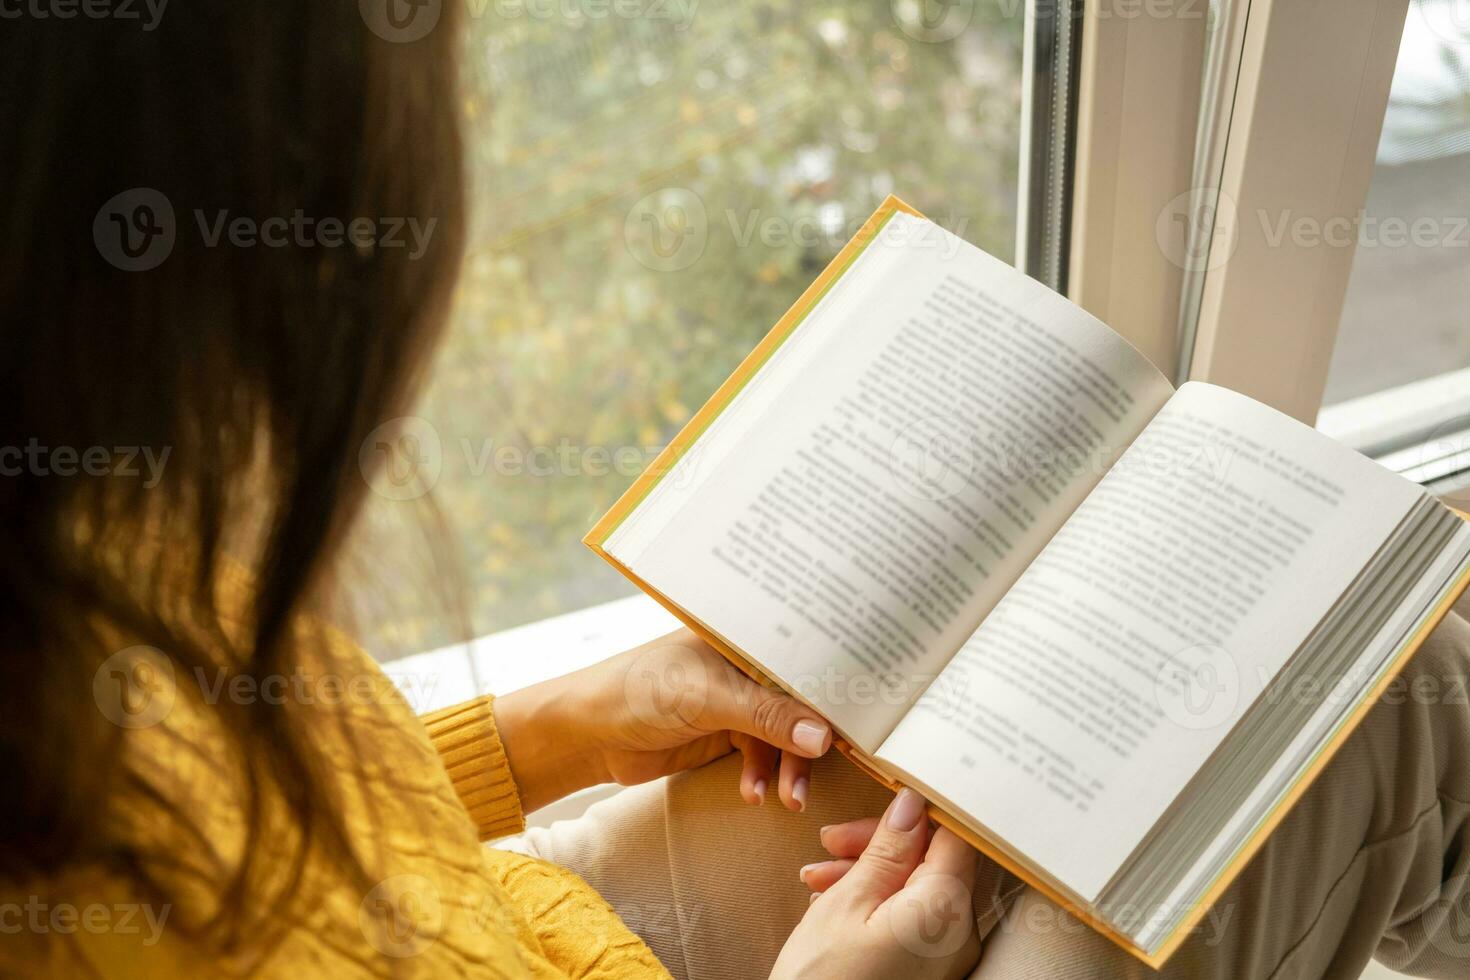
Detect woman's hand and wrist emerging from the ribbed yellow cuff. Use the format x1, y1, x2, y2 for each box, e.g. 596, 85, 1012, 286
495, 630, 832, 813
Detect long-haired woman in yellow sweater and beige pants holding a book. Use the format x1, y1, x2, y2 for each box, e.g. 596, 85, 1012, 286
0, 0, 1470, 979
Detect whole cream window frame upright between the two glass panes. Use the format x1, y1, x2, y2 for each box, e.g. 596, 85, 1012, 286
1067, 0, 1440, 423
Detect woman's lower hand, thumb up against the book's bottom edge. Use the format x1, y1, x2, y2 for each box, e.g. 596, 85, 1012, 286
770, 789, 980, 980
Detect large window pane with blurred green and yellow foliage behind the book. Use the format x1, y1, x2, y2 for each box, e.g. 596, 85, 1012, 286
362, 0, 1022, 657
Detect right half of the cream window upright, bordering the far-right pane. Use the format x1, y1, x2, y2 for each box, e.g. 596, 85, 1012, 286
1186, 0, 1408, 423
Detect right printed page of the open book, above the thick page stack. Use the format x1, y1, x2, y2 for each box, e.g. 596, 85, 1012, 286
878, 382, 1421, 901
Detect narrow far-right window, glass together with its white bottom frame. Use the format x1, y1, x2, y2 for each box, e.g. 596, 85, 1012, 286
1319, 0, 1470, 508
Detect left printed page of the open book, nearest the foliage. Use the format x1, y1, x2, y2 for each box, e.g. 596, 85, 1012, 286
607, 215, 1172, 751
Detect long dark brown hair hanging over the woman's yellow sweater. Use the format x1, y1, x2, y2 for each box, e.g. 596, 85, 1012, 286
0, 0, 463, 948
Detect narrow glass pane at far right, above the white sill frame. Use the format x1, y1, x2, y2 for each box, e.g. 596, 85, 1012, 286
1323, 0, 1470, 406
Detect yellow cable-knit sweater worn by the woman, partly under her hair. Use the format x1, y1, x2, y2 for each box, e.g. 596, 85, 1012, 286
0, 599, 667, 980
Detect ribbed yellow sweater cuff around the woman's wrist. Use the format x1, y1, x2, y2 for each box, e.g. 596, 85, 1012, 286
420, 695, 526, 840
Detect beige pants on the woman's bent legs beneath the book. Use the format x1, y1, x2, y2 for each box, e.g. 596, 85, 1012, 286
509, 616, 1470, 980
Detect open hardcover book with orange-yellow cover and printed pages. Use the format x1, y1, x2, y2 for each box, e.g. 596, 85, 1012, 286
587, 198, 1470, 967
